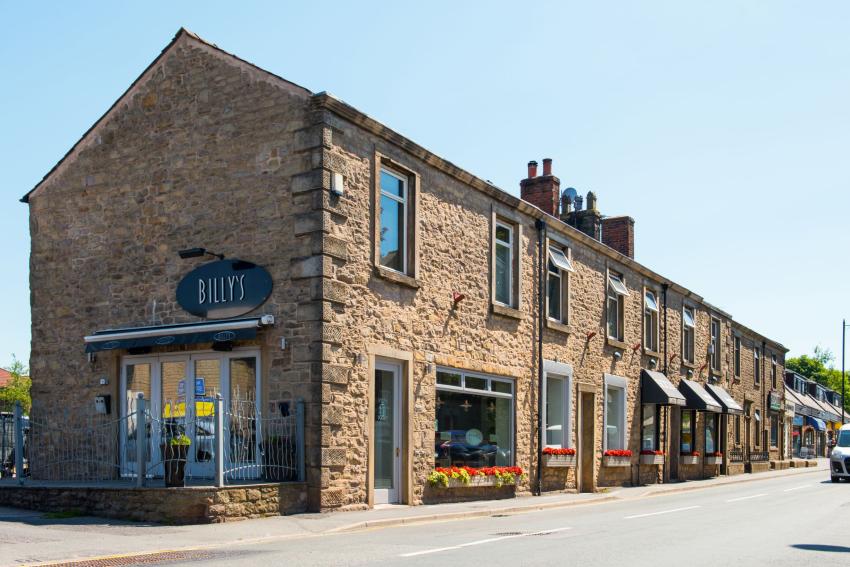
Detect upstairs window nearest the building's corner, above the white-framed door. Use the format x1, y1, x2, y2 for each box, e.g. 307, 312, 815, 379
378, 167, 408, 273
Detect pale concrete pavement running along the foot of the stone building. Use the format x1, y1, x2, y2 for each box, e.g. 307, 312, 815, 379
0, 460, 832, 565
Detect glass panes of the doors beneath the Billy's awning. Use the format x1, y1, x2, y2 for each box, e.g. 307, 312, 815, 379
121, 352, 259, 478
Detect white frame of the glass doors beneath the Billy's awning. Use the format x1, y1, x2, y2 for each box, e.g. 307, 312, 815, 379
120, 347, 262, 478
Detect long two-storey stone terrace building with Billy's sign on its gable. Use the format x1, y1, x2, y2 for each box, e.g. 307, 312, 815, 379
19, 30, 786, 510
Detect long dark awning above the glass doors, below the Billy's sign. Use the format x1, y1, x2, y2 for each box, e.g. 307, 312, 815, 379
85, 317, 262, 352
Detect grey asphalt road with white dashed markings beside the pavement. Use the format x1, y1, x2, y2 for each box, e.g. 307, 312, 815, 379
164, 475, 850, 567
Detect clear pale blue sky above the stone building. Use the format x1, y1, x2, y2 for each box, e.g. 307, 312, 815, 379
0, 0, 850, 365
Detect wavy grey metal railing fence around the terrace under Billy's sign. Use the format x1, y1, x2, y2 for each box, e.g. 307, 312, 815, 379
6, 396, 304, 486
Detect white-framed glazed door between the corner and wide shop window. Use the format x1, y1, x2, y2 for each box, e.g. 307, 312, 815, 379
374, 363, 401, 504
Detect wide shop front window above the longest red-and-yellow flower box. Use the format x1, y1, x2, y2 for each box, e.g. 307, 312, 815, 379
434, 370, 514, 467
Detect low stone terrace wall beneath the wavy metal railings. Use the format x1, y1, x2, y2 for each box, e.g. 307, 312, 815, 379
0, 483, 307, 524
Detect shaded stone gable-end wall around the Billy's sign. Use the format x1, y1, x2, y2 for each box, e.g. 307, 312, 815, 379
29, 32, 321, 508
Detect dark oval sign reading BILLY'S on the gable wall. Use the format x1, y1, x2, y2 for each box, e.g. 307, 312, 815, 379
177, 259, 272, 319
